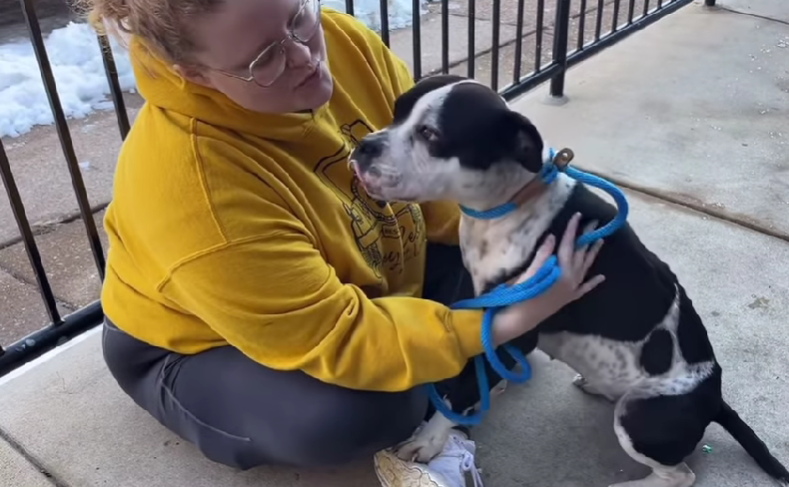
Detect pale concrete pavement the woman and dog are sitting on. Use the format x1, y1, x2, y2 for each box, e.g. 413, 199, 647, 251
0, 0, 789, 487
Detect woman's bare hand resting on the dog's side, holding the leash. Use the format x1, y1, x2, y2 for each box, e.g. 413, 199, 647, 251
493, 213, 605, 346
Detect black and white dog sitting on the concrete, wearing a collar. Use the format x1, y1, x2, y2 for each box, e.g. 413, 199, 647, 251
351, 76, 789, 487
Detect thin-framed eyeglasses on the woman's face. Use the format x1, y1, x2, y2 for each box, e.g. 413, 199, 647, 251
215, 0, 321, 88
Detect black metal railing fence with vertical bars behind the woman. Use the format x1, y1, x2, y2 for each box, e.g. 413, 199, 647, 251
0, 0, 700, 376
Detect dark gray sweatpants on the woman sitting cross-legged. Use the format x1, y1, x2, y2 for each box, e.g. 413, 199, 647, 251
103, 244, 473, 469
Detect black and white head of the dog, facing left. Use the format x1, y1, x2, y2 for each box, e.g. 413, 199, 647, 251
350, 75, 543, 204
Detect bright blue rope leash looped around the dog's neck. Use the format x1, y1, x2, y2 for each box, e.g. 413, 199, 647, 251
429, 149, 629, 425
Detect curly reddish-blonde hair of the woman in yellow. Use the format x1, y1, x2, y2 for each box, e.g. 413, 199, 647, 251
75, 0, 223, 63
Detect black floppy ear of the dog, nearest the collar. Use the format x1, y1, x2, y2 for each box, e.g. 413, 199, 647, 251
494, 109, 543, 173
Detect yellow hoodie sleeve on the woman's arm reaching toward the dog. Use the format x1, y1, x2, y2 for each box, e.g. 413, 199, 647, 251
160, 194, 482, 391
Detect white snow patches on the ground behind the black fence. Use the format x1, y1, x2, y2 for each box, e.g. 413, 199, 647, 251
0, 0, 427, 137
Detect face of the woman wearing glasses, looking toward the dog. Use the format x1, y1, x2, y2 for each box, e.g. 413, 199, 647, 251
181, 0, 334, 113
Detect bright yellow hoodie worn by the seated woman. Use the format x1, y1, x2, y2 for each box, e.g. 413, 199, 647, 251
102, 9, 482, 391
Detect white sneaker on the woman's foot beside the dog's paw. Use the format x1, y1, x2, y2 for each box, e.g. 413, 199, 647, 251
374, 430, 483, 487
